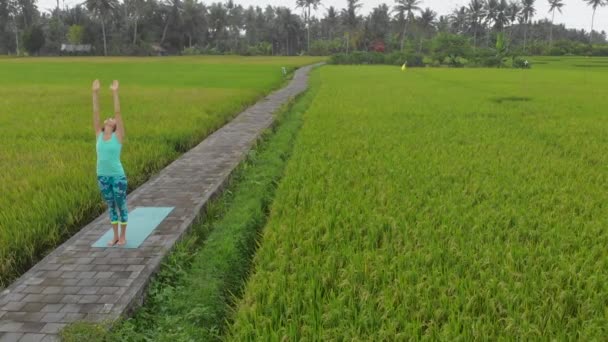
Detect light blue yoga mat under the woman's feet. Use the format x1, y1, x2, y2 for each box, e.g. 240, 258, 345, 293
92, 207, 174, 248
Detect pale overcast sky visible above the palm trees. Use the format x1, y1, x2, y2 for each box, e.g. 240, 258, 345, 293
38, 0, 608, 32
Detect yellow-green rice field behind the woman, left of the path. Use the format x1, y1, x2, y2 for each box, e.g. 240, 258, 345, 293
0, 56, 319, 288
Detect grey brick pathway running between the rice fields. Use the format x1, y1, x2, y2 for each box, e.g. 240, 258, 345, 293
0, 66, 320, 342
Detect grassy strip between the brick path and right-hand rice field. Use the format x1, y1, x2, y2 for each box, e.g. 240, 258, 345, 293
62, 67, 317, 342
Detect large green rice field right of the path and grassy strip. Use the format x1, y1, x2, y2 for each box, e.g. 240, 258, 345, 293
228, 58, 608, 341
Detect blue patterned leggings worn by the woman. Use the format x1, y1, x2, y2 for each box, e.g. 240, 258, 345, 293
97, 176, 129, 225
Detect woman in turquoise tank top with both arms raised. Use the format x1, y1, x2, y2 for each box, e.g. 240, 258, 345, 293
93, 80, 128, 247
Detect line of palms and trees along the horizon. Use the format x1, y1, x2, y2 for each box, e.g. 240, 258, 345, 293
0, 0, 608, 55
